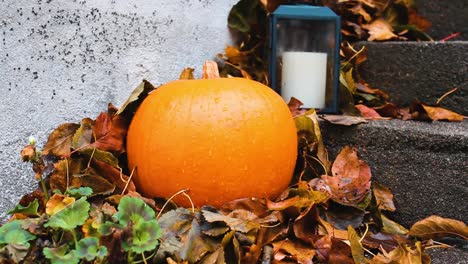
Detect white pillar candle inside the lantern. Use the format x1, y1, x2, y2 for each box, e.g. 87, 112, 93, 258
281, 51, 327, 109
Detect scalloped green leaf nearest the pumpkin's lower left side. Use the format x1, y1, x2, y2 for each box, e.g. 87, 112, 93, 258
114, 196, 156, 226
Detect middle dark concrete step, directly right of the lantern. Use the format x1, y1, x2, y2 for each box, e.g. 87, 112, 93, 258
356, 41, 468, 115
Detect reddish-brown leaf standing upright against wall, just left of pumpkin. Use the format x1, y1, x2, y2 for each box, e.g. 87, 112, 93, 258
91, 104, 128, 154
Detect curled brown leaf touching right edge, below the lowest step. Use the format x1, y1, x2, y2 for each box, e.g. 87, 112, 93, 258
408, 215, 468, 240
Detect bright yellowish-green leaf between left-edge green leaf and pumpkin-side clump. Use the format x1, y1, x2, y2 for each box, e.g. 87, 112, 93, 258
45, 197, 90, 230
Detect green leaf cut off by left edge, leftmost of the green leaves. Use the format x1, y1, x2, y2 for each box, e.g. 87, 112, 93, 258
0, 220, 36, 247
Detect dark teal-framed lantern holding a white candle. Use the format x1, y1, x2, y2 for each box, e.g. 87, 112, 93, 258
269, 5, 341, 113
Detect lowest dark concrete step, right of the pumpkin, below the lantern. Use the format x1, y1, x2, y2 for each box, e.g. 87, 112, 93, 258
321, 120, 468, 264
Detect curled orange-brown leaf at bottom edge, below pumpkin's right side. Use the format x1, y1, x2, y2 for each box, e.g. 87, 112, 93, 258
273, 239, 316, 264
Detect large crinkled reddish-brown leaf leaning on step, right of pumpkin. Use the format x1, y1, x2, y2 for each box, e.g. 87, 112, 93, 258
315, 147, 371, 205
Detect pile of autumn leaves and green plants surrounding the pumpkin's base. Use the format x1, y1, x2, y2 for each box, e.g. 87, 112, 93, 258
0, 78, 468, 263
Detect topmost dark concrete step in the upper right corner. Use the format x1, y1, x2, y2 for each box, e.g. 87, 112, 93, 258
415, 0, 468, 40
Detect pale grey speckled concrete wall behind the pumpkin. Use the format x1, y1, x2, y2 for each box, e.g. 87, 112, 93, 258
0, 0, 237, 222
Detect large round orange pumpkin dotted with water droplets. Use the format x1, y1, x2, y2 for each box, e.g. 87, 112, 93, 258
127, 62, 297, 207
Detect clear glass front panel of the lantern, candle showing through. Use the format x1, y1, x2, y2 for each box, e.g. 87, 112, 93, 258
274, 18, 339, 109
